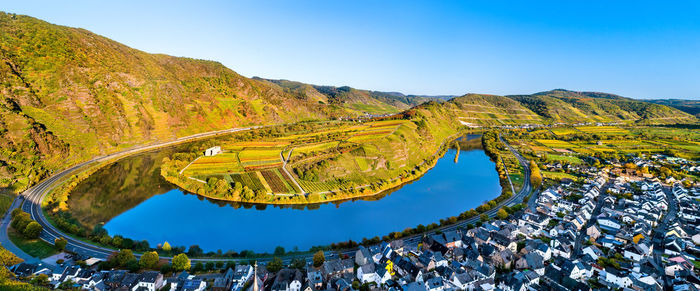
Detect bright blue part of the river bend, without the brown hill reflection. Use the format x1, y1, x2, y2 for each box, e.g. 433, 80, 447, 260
105, 144, 501, 252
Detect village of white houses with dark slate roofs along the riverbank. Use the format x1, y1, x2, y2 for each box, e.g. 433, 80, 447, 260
5, 151, 700, 291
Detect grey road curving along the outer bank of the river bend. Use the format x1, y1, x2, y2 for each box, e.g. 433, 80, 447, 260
0, 130, 532, 263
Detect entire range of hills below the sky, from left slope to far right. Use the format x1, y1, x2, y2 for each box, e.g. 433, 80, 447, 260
0, 12, 696, 194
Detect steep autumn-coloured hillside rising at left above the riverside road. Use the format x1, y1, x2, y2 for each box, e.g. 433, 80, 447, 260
0, 13, 413, 193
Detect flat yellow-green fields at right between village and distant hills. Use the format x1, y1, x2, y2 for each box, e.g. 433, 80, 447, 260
511, 125, 700, 187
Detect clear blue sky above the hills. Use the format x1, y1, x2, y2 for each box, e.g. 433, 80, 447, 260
0, 0, 700, 99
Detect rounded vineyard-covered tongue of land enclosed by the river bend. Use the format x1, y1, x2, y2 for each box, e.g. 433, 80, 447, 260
161, 105, 462, 204
